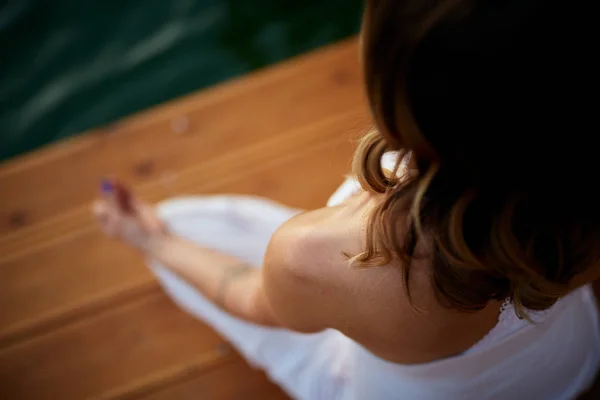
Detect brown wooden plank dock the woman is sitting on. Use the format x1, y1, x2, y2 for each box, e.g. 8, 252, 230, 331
0, 39, 369, 400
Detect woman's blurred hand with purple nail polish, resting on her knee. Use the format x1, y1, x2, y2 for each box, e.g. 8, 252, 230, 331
93, 180, 168, 250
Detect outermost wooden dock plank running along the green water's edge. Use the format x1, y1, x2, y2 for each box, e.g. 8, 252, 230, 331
0, 40, 366, 238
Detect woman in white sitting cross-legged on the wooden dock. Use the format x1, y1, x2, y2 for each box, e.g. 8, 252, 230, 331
95, 0, 600, 400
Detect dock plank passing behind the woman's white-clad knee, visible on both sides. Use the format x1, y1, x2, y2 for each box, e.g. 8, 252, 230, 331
0, 125, 360, 346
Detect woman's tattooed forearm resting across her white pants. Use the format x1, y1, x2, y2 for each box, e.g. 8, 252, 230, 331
145, 235, 277, 325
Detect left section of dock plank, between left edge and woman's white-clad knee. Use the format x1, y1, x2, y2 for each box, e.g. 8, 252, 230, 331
0, 230, 151, 347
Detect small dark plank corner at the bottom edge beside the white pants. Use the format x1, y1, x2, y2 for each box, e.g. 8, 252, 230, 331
140, 358, 289, 400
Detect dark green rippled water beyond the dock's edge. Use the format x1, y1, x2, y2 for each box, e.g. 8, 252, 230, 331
0, 0, 362, 160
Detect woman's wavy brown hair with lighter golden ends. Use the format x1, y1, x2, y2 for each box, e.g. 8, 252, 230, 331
352, 0, 600, 316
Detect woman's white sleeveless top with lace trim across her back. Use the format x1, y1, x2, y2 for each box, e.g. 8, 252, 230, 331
328, 154, 600, 400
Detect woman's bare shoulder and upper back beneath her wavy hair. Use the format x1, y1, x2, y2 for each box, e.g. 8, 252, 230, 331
264, 195, 498, 363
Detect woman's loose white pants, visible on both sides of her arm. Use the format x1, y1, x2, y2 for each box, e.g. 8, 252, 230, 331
149, 196, 349, 400
